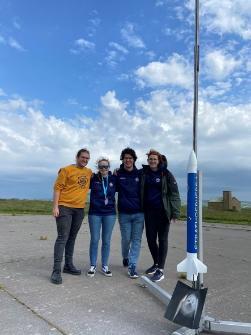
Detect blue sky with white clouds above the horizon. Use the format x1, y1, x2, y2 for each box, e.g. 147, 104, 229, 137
0, 0, 251, 201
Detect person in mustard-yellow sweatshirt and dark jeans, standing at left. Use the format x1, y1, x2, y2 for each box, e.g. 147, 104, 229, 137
50, 149, 92, 284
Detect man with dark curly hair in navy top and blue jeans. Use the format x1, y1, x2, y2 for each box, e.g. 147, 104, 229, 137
116, 148, 144, 278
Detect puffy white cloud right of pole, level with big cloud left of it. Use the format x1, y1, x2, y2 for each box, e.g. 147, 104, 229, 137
205, 50, 241, 80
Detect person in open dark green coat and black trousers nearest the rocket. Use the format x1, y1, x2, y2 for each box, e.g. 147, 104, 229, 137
141, 149, 181, 282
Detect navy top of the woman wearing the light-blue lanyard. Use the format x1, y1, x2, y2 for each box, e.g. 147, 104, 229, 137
89, 172, 117, 216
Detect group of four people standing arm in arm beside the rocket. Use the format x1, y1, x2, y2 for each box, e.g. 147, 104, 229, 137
50, 147, 181, 284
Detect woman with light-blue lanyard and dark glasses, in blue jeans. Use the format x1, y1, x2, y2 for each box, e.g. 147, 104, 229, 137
87, 157, 117, 277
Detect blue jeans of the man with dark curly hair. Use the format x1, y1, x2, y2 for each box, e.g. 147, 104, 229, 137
119, 213, 144, 267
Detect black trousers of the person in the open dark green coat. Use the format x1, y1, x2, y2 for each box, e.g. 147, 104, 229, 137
145, 209, 170, 269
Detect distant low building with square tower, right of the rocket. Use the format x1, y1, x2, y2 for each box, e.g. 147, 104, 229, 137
208, 191, 241, 212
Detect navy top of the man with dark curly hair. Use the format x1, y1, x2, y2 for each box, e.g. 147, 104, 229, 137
117, 164, 142, 214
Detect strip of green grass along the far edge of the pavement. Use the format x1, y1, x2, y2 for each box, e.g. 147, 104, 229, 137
0, 199, 251, 225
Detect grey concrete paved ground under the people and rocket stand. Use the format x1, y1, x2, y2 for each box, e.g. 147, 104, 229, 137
0, 216, 251, 335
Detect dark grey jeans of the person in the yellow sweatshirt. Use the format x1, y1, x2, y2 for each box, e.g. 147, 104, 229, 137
53, 206, 84, 270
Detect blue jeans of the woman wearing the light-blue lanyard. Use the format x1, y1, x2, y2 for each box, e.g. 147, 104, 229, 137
88, 215, 116, 266
